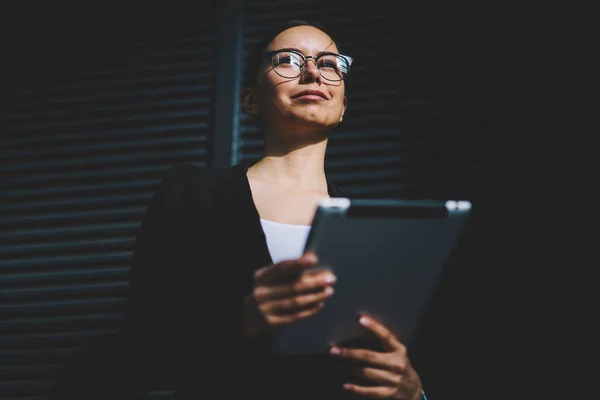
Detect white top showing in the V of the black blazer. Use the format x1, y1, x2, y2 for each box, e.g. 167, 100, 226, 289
260, 218, 310, 264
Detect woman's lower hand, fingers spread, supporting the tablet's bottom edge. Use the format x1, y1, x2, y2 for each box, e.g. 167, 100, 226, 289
331, 316, 421, 400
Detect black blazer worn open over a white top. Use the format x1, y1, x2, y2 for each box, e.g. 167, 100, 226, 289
53, 163, 358, 400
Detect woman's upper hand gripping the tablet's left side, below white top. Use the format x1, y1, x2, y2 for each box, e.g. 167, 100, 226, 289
244, 252, 336, 338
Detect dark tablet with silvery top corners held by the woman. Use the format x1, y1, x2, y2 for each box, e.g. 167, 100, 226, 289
272, 198, 471, 355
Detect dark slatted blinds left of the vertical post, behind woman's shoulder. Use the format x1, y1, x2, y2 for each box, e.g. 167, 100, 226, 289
0, 10, 214, 399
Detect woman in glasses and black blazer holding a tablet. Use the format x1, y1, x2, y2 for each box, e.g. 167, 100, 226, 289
52, 21, 422, 400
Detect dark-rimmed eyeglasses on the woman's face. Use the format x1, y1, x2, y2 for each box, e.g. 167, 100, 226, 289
265, 49, 354, 82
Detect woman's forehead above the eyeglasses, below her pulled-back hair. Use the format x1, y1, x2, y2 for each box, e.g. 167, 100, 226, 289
266, 26, 338, 56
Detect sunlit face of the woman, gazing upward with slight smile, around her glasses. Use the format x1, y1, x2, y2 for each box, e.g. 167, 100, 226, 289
244, 26, 346, 138
